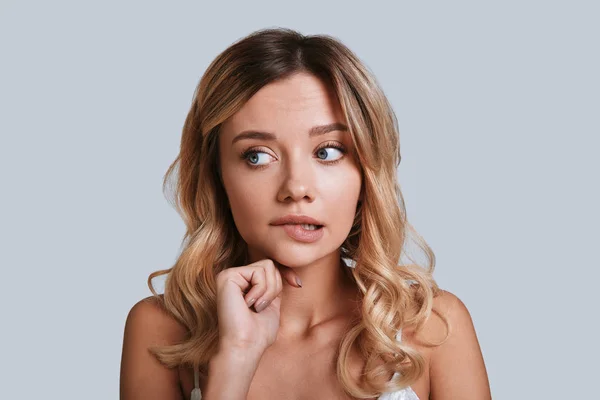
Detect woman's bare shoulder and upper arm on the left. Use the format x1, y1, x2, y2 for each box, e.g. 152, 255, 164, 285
120, 296, 186, 400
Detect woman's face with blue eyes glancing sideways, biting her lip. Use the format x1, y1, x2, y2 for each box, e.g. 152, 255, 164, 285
219, 73, 361, 267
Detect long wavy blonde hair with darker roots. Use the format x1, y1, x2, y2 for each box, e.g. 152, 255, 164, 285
148, 28, 448, 398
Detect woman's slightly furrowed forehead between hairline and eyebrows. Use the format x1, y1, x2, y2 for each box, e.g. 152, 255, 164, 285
223, 73, 344, 140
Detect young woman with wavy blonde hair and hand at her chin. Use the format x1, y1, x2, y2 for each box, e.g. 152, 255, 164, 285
120, 29, 491, 400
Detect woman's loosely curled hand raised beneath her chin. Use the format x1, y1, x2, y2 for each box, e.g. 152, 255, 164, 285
217, 259, 301, 354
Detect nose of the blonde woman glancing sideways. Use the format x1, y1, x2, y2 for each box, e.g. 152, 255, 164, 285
277, 152, 315, 203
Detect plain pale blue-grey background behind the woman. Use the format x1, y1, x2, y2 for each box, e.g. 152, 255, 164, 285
0, 0, 600, 399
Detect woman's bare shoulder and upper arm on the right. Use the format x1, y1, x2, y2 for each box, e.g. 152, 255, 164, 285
429, 290, 491, 400
